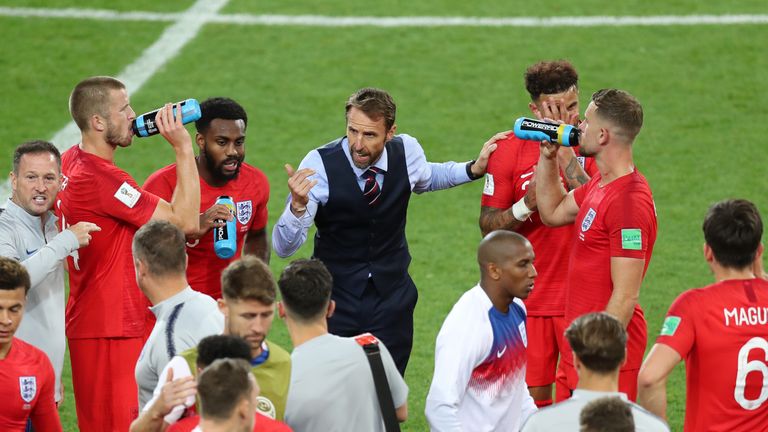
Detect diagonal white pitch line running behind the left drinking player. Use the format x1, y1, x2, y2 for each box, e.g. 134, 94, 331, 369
0, 0, 229, 206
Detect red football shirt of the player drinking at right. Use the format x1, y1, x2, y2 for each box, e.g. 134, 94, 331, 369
564, 170, 656, 370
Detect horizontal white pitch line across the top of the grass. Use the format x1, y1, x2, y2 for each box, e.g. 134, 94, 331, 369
0, 7, 768, 27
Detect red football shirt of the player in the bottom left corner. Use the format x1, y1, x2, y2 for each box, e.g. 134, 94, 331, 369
0, 338, 61, 432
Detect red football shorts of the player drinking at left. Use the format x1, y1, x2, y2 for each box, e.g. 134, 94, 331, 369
69, 337, 144, 432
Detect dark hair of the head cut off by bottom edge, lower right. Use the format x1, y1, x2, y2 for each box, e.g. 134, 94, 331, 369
579, 396, 635, 432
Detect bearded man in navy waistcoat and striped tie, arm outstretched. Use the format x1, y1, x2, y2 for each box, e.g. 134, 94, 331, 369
272, 87, 500, 374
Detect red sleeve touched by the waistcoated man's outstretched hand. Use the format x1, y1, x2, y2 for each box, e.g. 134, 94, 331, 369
481, 138, 516, 210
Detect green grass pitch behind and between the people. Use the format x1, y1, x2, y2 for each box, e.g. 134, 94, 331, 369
0, 0, 768, 431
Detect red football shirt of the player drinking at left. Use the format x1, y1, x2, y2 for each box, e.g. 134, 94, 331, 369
56, 146, 159, 339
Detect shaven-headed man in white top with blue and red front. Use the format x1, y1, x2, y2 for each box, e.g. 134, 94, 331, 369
426, 231, 536, 431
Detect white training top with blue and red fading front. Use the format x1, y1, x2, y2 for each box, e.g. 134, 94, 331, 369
426, 285, 536, 432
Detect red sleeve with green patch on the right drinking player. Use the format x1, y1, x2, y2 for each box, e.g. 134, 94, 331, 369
605, 191, 654, 259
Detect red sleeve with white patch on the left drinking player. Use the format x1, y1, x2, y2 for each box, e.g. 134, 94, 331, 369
99, 167, 160, 227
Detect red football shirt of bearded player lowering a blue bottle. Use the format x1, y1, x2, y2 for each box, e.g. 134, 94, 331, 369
144, 163, 269, 299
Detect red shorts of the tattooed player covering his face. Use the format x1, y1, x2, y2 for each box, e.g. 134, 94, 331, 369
525, 316, 568, 387
